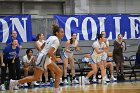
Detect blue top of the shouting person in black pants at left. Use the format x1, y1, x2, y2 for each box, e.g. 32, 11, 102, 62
3, 45, 20, 59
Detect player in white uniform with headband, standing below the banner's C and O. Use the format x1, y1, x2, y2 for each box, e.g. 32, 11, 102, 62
63, 33, 80, 84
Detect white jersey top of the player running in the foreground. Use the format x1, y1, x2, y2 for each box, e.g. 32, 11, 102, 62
41, 36, 60, 55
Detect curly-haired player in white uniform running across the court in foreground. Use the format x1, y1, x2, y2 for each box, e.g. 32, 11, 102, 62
9, 25, 64, 93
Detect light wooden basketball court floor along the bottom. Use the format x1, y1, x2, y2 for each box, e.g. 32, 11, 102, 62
0, 81, 140, 93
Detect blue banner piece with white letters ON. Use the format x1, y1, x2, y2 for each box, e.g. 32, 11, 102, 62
0, 15, 32, 43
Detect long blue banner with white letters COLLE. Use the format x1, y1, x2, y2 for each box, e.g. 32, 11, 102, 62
54, 14, 140, 40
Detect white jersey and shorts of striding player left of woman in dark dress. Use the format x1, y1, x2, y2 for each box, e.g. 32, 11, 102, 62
91, 41, 105, 63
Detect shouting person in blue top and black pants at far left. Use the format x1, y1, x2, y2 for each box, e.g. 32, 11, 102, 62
1, 39, 20, 89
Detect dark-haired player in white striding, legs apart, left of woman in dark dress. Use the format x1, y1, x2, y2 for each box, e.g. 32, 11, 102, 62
84, 34, 108, 84
